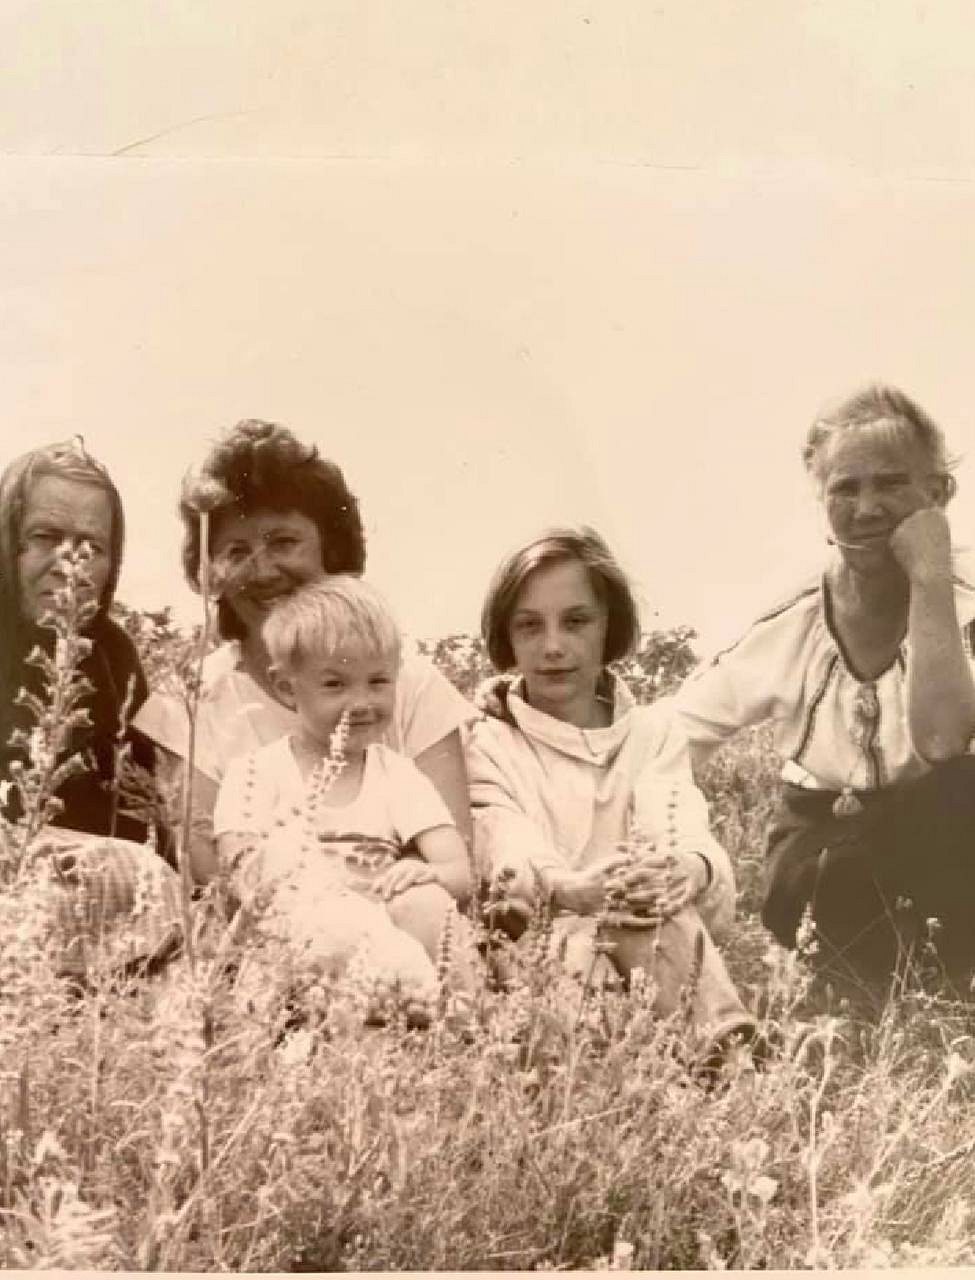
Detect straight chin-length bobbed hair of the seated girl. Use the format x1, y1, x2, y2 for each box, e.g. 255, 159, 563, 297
481, 525, 640, 671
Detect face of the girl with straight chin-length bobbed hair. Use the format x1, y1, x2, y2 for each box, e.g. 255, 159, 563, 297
508, 559, 608, 726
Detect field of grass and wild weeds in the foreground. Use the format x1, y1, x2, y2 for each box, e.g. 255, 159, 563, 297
0, 604, 975, 1271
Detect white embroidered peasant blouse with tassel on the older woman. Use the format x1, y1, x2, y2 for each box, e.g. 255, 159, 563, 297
676, 579, 975, 791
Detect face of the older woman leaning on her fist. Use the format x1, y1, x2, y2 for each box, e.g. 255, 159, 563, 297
816, 421, 946, 568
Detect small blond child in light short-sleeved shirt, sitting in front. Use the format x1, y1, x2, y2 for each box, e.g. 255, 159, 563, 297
214, 575, 473, 997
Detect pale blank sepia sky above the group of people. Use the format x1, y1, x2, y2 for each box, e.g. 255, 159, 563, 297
0, 0, 975, 645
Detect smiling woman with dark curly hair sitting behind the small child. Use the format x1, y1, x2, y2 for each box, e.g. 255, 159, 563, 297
137, 420, 476, 882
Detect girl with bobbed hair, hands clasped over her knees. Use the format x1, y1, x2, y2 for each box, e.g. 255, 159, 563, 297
467, 529, 754, 1051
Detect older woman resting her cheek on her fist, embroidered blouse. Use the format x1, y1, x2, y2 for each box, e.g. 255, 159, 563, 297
677, 385, 975, 992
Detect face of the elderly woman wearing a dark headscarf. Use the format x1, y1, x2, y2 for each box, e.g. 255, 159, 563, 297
17, 475, 111, 622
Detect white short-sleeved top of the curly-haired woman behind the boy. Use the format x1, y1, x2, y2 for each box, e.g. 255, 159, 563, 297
134, 640, 477, 782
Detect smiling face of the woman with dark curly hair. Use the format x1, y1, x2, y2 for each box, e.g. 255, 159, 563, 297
210, 511, 325, 635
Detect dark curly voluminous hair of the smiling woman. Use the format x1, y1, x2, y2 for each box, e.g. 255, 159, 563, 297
179, 419, 366, 639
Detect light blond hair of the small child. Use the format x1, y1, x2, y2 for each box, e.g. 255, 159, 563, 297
261, 573, 402, 672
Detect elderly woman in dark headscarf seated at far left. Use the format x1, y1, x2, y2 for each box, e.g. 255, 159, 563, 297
0, 436, 179, 973
